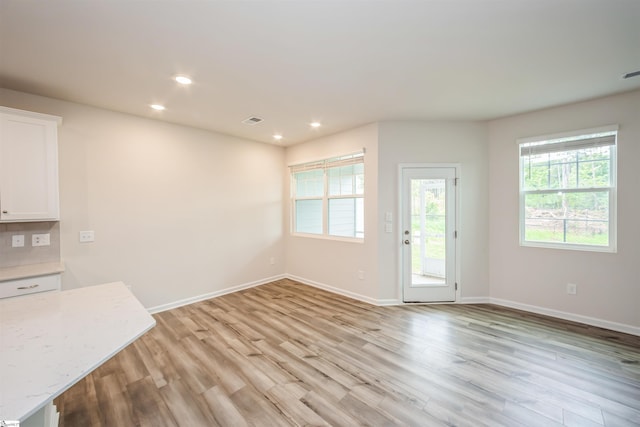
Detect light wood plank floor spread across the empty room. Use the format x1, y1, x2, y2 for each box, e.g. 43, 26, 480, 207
55, 280, 640, 427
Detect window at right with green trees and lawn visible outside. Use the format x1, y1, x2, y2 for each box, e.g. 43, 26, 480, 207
518, 126, 617, 252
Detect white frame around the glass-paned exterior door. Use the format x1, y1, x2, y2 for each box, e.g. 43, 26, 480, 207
396, 163, 462, 304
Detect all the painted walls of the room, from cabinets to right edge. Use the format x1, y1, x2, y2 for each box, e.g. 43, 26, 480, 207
0, 89, 640, 330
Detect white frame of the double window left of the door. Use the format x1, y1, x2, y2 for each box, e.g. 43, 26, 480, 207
289, 149, 366, 243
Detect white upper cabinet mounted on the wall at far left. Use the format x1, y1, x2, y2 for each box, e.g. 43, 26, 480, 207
0, 107, 62, 222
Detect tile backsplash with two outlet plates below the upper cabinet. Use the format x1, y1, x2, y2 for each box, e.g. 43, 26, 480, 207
0, 221, 60, 268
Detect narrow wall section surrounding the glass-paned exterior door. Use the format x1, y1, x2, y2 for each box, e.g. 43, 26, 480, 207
378, 122, 489, 301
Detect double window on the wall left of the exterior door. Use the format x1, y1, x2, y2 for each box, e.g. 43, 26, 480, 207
291, 152, 364, 239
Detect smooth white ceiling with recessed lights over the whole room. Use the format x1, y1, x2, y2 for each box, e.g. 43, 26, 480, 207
0, 0, 640, 145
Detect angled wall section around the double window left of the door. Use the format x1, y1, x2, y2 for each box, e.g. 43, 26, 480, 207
284, 125, 379, 302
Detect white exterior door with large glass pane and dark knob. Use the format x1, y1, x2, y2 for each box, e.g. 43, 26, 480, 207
401, 166, 457, 302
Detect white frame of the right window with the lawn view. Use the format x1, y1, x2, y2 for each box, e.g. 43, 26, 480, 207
517, 125, 618, 253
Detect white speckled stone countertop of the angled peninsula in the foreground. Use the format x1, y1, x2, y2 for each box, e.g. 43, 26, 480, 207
0, 282, 156, 421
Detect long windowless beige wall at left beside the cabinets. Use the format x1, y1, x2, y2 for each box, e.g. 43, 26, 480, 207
0, 89, 285, 307
